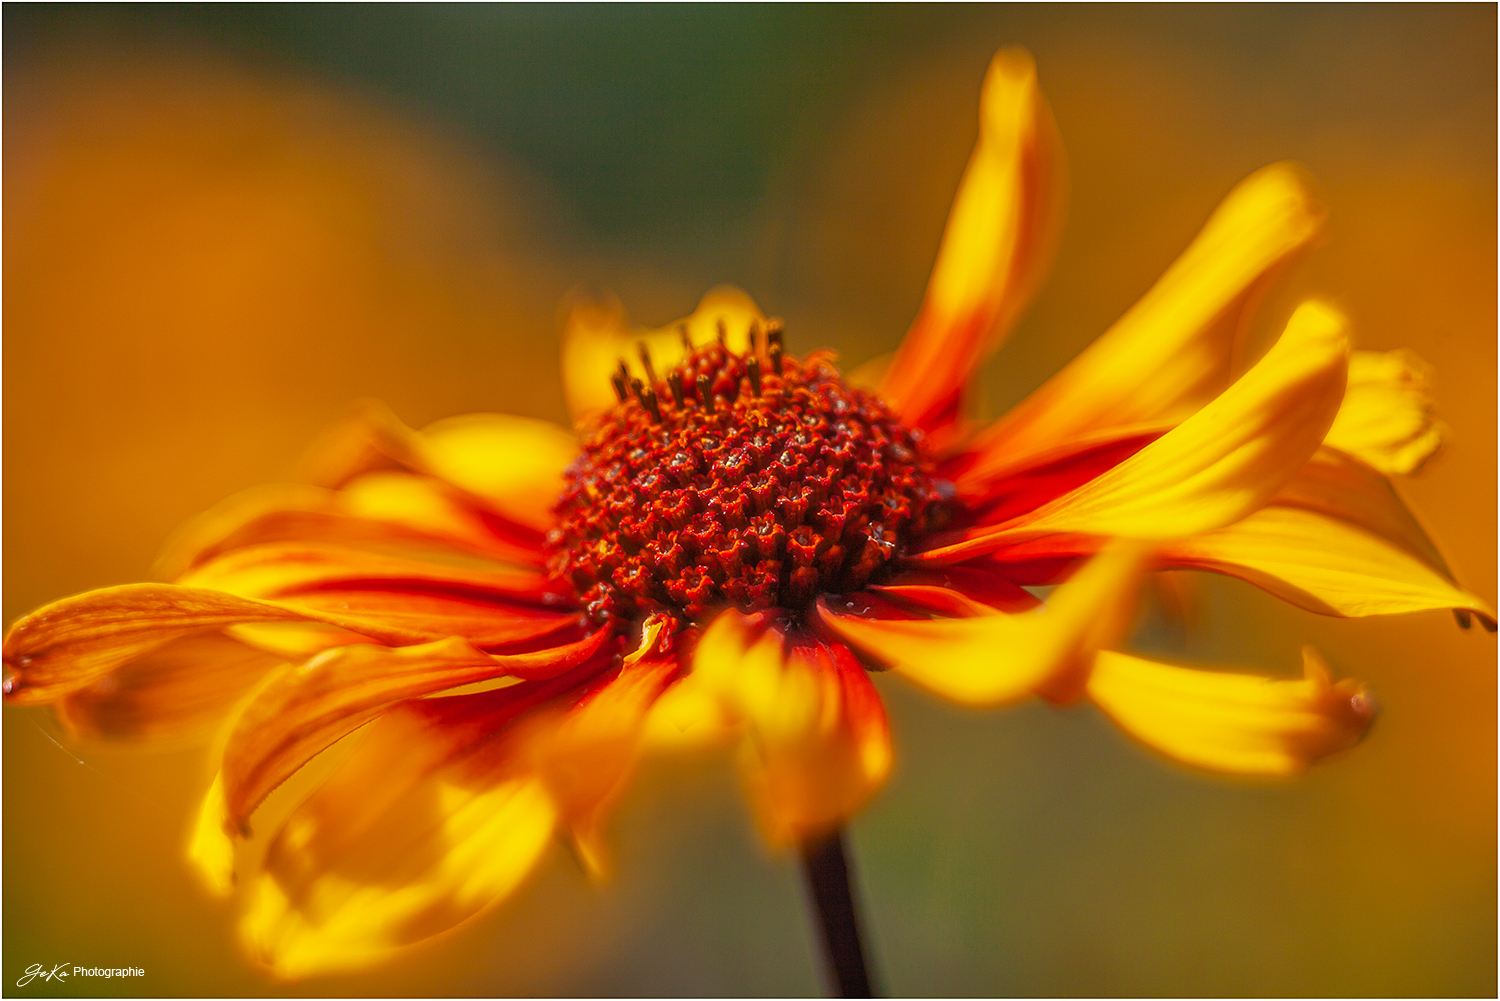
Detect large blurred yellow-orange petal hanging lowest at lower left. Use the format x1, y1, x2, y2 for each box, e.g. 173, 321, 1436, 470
245, 633, 677, 977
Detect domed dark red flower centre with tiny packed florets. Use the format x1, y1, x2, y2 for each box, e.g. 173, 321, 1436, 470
546, 327, 938, 624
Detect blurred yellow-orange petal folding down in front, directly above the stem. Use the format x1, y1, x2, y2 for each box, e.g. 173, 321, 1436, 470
693, 611, 893, 845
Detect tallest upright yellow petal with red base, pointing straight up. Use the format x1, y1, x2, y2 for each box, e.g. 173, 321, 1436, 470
881, 50, 1065, 431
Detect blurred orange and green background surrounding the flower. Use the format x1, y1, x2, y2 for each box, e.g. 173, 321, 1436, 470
0, 3, 1497, 995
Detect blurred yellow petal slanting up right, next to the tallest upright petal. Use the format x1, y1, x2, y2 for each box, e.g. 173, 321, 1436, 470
975, 164, 1325, 474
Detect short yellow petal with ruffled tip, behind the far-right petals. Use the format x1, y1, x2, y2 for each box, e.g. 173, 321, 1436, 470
1325, 351, 1448, 476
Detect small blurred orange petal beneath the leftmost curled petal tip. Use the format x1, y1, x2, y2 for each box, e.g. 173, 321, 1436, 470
56, 633, 284, 743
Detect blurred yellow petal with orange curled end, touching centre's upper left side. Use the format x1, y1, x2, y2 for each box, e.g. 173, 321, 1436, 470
305, 402, 578, 542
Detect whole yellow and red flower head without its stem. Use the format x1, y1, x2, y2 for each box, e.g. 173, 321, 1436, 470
5, 51, 1494, 975
